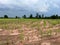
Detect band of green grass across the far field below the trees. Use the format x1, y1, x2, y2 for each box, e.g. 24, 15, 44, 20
0, 19, 60, 30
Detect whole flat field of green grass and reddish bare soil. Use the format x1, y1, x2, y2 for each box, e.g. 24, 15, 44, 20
0, 19, 60, 45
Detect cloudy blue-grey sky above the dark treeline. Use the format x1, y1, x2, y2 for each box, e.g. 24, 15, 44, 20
0, 0, 60, 17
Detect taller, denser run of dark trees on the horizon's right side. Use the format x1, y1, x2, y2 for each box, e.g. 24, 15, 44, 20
23, 13, 60, 19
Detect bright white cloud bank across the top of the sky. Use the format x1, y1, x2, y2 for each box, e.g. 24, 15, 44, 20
0, 0, 60, 12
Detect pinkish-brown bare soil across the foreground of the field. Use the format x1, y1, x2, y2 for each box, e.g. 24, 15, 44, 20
0, 20, 60, 45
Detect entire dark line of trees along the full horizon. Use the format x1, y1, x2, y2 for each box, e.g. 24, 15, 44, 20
0, 13, 60, 19
